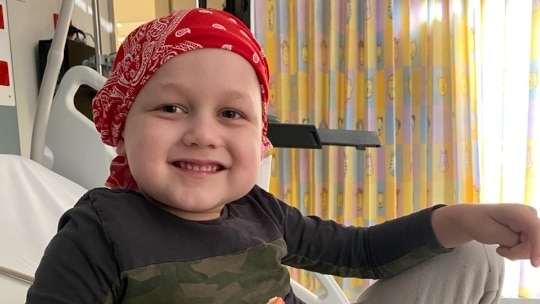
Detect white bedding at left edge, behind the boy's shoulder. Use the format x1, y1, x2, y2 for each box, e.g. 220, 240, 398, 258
0, 154, 86, 304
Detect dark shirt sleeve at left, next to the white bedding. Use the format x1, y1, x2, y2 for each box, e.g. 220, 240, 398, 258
26, 196, 119, 304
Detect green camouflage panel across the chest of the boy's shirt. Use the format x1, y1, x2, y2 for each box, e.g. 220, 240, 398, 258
105, 238, 290, 304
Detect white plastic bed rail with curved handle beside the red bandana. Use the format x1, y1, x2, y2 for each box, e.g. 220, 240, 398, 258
45, 66, 116, 189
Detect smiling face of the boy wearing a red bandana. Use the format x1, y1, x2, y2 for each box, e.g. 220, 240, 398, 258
117, 49, 263, 220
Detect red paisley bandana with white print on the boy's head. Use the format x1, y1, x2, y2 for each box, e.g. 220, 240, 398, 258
92, 8, 271, 189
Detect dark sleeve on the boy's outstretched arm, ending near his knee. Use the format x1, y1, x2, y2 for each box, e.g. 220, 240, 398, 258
278, 196, 450, 279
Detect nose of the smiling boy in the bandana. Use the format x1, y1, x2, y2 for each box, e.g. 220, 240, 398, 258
182, 116, 220, 147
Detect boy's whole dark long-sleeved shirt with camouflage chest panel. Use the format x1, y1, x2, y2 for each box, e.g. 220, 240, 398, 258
27, 187, 445, 304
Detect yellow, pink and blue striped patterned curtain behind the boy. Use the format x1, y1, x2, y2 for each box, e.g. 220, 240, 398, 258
252, 0, 480, 299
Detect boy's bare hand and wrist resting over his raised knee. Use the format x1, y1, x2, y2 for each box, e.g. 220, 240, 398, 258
431, 204, 540, 267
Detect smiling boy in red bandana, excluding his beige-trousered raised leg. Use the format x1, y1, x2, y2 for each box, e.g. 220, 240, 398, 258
27, 9, 540, 304
